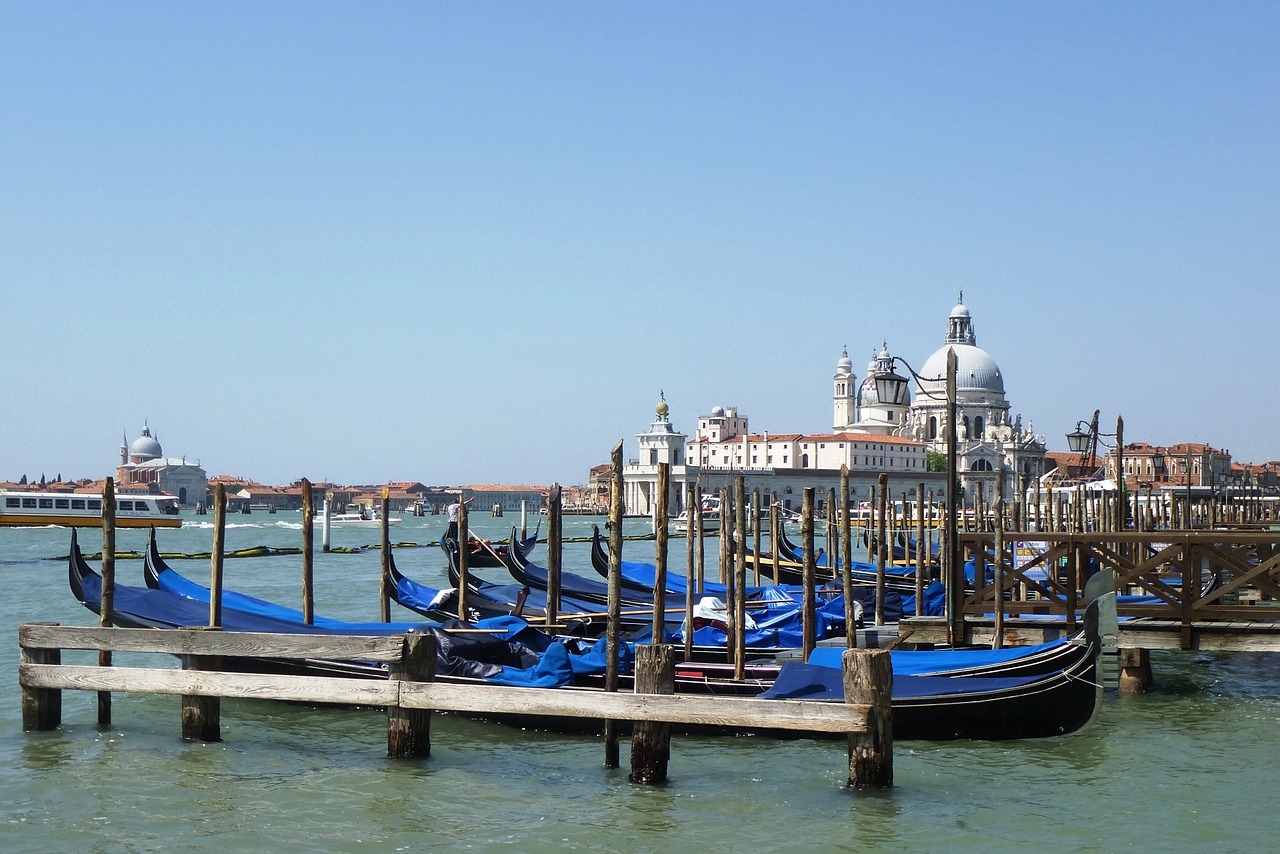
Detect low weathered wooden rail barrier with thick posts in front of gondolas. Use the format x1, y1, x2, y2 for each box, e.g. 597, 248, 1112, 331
18, 624, 892, 787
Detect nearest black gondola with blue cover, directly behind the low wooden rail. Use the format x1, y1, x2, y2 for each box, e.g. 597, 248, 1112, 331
68, 533, 1112, 739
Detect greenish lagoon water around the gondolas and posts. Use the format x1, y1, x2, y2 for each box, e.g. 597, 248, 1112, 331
0, 513, 1280, 854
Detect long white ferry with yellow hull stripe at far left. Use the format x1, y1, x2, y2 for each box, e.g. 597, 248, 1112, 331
0, 490, 182, 528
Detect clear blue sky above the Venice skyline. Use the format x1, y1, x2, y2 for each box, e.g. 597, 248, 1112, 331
0, 0, 1280, 484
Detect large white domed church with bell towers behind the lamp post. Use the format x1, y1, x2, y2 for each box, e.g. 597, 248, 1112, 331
835, 293, 1044, 501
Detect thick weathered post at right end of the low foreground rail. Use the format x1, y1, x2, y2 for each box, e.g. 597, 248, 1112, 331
841, 649, 893, 789
